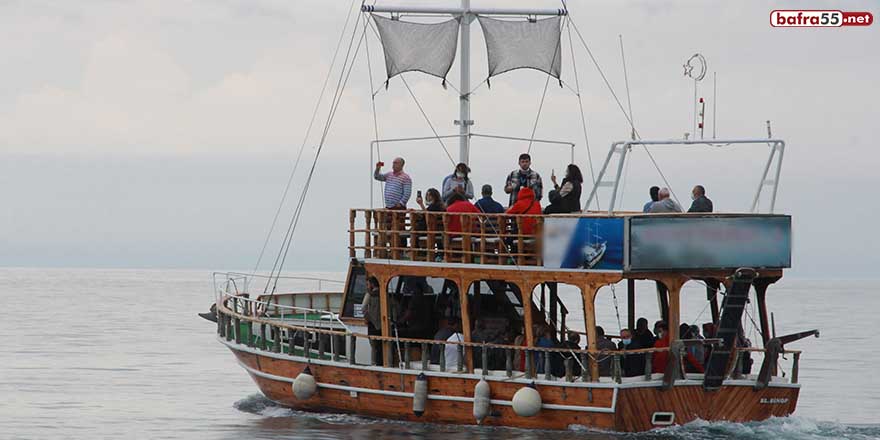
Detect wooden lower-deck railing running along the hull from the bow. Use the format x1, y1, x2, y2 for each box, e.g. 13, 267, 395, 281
217, 296, 800, 383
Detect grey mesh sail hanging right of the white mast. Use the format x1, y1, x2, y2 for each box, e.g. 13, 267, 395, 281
477, 16, 562, 79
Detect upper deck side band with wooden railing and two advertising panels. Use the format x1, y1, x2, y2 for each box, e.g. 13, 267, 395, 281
349, 209, 792, 273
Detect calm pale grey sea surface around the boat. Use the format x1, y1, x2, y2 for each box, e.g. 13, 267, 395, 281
0, 269, 880, 440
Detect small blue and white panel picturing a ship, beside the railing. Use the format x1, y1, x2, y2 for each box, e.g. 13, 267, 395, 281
544, 217, 624, 270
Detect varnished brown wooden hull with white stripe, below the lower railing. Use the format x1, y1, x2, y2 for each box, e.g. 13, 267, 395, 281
221, 340, 800, 432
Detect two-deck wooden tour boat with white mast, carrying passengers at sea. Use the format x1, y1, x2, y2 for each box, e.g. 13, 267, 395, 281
206, 0, 818, 431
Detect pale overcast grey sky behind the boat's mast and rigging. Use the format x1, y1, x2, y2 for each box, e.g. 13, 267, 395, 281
0, 0, 880, 278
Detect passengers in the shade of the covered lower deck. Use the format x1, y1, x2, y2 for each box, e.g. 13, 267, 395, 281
362, 277, 752, 377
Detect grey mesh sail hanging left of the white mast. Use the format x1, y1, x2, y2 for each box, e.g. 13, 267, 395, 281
372, 14, 460, 81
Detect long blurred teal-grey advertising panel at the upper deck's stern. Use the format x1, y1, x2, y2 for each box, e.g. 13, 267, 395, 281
627, 215, 791, 270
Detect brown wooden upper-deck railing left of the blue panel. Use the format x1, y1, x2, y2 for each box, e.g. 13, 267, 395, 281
348, 209, 544, 266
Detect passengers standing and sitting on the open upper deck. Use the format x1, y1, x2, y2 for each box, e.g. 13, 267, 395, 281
373, 153, 713, 233
